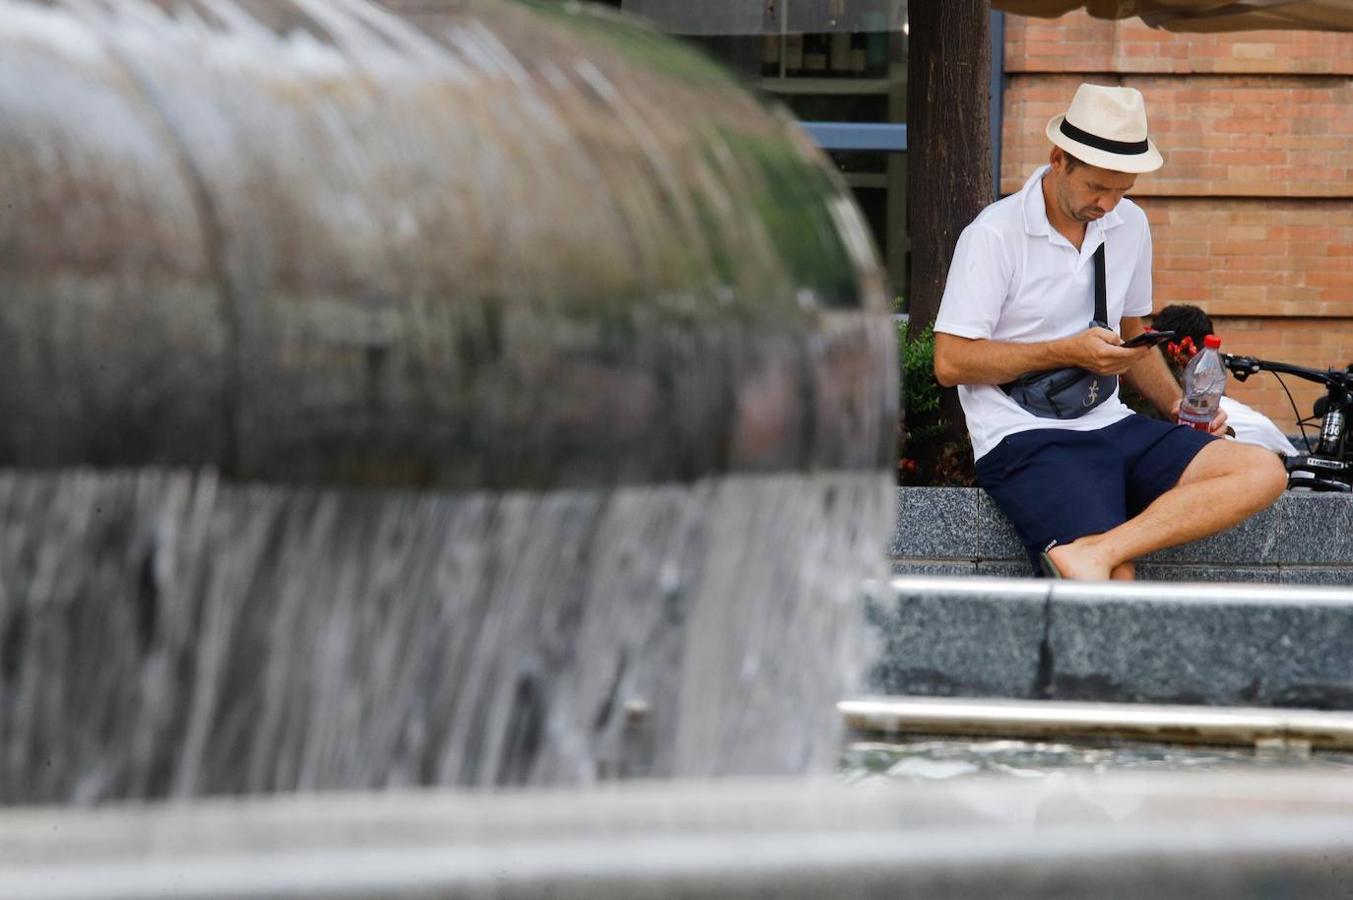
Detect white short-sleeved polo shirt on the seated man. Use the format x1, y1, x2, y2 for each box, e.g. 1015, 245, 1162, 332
935, 165, 1151, 459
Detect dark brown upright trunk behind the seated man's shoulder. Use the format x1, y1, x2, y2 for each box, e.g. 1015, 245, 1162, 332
905, 0, 993, 471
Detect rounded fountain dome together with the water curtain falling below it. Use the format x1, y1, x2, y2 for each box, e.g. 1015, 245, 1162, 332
0, 0, 897, 803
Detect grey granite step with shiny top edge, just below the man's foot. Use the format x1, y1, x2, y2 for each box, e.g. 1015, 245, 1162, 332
865, 577, 1353, 709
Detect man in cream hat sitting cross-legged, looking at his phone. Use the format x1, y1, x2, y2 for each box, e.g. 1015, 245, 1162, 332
935, 84, 1287, 579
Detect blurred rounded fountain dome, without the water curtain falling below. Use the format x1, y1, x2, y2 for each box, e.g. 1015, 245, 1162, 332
0, 0, 894, 486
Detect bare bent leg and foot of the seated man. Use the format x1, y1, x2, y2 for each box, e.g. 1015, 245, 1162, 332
1049, 441, 1287, 581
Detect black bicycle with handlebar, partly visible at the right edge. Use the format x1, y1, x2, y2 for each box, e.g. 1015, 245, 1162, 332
1222, 353, 1353, 494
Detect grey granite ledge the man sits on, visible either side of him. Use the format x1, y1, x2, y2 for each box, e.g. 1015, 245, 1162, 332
889, 487, 1353, 585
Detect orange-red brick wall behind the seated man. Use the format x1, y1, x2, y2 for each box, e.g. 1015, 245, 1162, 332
1001, 14, 1353, 430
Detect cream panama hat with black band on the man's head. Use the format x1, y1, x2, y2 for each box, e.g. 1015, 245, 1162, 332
1047, 84, 1164, 175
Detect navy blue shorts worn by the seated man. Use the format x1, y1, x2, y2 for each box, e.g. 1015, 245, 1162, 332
977, 415, 1216, 571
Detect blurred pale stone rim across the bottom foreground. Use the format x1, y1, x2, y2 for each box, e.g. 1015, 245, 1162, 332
0, 771, 1353, 900
